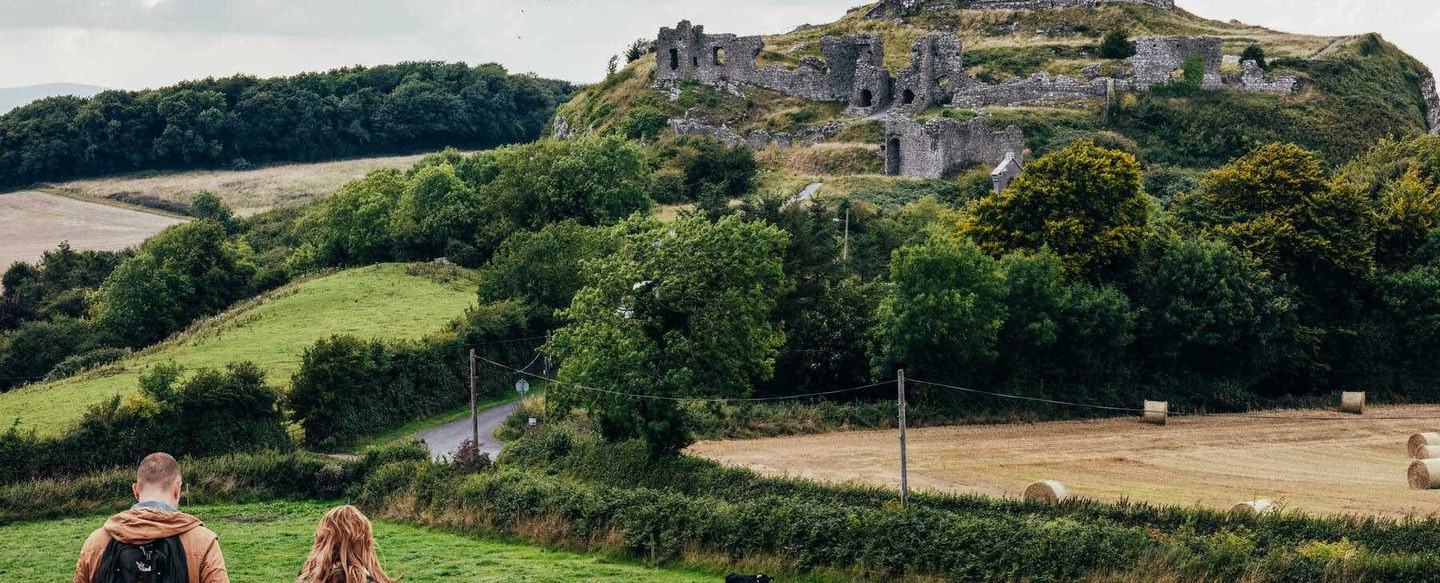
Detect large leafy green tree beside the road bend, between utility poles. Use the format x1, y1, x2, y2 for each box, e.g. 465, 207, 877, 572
549, 216, 788, 455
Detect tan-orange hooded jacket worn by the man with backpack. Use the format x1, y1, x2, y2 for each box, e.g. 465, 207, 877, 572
75, 508, 230, 583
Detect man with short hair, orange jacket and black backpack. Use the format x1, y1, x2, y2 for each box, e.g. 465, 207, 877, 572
75, 453, 230, 583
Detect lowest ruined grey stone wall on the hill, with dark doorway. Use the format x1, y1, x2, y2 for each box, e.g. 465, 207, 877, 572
884, 115, 1025, 178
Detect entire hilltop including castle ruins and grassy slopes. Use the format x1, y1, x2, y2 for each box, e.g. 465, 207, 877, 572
556, 0, 1440, 188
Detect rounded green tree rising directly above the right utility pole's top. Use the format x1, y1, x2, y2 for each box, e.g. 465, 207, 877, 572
873, 228, 1005, 381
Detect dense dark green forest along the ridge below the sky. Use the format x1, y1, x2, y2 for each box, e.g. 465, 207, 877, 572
0, 62, 573, 186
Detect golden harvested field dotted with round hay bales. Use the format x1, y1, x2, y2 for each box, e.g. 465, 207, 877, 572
690, 406, 1440, 517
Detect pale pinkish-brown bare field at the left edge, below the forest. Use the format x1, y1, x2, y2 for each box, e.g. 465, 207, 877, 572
0, 191, 183, 269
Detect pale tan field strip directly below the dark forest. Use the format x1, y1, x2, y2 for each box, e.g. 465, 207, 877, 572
53, 154, 455, 216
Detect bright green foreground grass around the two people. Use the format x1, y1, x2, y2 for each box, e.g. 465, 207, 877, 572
0, 502, 719, 583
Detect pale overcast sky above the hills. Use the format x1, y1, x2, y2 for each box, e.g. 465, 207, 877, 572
0, 0, 1440, 89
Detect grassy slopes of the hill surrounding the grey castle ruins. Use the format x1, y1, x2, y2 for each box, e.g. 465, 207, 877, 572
559, 4, 1426, 176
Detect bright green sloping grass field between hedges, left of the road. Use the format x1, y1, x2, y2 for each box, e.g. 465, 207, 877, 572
0, 263, 475, 435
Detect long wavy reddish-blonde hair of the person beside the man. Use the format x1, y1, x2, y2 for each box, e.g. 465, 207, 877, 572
295, 505, 396, 583
